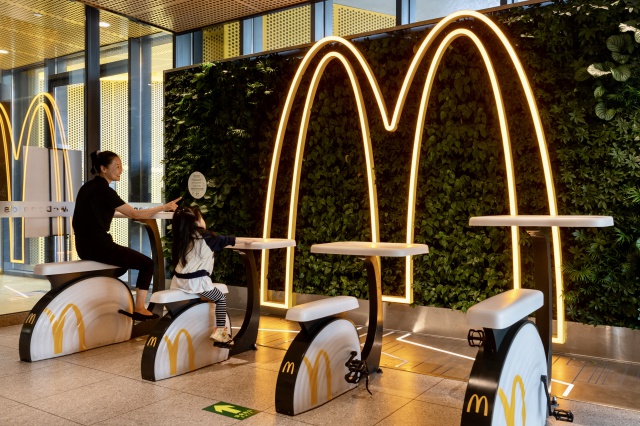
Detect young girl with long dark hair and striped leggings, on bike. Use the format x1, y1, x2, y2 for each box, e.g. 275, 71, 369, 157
171, 207, 236, 347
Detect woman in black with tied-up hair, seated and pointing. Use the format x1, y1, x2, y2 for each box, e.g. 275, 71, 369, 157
72, 151, 180, 321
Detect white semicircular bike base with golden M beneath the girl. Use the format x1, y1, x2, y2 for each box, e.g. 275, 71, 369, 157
141, 299, 231, 382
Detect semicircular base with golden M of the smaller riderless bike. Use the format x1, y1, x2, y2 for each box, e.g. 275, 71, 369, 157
275, 306, 362, 416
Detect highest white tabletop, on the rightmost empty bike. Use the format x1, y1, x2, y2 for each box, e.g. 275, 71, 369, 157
469, 215, 613, 228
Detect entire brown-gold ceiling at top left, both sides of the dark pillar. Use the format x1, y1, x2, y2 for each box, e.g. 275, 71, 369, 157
0, 0, 307, 70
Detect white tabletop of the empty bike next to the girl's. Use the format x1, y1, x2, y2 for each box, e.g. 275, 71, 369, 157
311, 241, 429, 257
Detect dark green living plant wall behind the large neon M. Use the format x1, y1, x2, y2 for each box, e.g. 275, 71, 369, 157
165, 0, 640, 328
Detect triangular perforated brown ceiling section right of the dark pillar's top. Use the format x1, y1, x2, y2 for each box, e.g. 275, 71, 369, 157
81, 0, 307, 33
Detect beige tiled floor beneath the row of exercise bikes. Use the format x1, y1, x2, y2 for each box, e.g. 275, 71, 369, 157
0, 311, 640, 426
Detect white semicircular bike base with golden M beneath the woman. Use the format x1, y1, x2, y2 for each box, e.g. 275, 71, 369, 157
19, 269, 133, 362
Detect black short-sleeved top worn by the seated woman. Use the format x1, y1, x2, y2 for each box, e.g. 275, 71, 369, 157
72, 176, 125, 250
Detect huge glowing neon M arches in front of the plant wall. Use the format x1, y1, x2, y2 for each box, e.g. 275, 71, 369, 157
260, 11, 565, 343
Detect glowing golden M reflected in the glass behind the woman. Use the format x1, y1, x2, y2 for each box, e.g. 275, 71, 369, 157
0, 92, 74, 263
